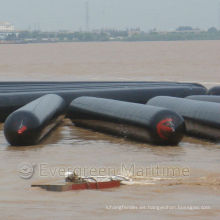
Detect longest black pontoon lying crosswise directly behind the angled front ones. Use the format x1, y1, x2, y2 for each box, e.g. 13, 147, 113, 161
0, 85, 206, 122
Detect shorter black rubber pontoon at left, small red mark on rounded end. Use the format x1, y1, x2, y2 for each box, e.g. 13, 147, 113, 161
4, 94, 66, 146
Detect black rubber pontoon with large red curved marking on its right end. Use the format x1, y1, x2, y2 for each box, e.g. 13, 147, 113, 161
67, 97, 185, 145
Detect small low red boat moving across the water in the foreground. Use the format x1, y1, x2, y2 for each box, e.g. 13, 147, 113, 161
31, 172, 129, 192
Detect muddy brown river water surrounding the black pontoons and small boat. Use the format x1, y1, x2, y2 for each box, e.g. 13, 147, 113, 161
0, 41, 220, 220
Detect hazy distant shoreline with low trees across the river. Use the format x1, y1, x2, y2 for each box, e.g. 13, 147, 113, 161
0, 28, 220, 44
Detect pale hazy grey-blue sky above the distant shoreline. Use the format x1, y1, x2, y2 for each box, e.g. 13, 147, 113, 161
0, 0, 220, 30
